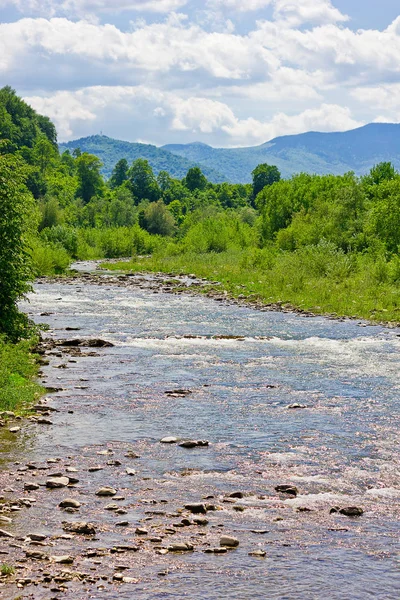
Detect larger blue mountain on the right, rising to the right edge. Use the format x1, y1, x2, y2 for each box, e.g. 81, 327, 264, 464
163, 123, 400, 183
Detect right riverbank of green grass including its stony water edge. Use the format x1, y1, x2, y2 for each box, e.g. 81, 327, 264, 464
102, 252, 400, 327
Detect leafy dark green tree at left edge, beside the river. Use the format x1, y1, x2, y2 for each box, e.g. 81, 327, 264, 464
0, 154, 35, 341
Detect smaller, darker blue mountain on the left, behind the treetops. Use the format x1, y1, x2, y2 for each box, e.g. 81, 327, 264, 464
59, 135, 226, 183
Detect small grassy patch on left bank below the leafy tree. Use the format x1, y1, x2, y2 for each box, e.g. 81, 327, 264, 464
0, 339, 43, 414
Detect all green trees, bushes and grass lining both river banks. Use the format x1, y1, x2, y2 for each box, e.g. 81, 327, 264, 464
0, 87, 400, 409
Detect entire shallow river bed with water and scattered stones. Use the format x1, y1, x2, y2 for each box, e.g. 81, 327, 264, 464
0, 274, 400, 600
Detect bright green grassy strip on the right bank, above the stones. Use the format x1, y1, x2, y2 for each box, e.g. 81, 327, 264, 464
104, 245, 400, 324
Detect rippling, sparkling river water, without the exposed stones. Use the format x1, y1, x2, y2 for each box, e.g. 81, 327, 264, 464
3, 280, 400, 600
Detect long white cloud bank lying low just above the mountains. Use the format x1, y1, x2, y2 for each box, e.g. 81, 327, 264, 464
26, 86, 362, 146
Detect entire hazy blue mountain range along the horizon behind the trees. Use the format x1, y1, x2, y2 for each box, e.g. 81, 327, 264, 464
60, 123, 400, 183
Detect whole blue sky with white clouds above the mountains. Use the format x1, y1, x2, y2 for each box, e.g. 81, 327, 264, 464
0, 0, 400, 147
